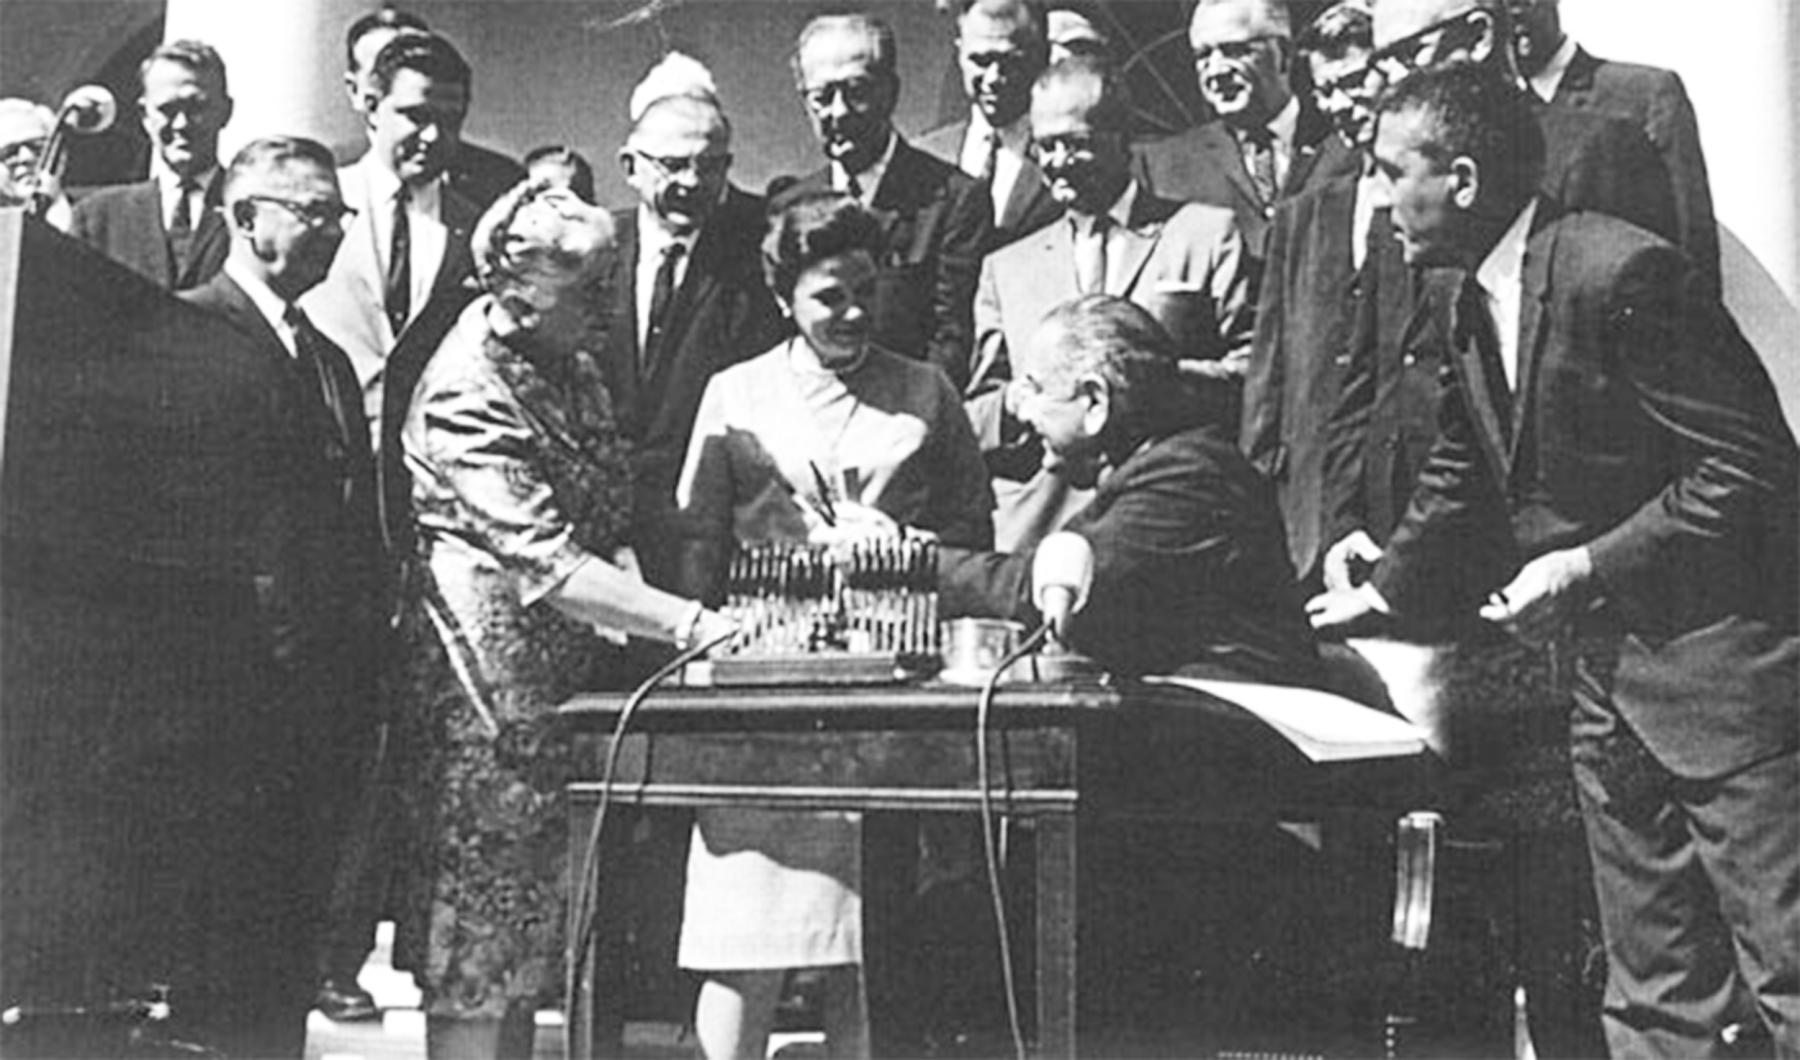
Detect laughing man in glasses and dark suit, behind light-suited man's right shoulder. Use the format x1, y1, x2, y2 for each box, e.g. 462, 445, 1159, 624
1138, 0, 1355, 259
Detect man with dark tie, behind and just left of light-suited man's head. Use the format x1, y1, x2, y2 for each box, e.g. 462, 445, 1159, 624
918, 0, 1062, 247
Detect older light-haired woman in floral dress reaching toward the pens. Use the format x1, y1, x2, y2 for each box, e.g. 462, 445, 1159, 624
396, 184, 731, 1058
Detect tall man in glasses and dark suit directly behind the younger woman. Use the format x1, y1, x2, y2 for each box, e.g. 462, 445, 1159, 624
769, 13, 994, 385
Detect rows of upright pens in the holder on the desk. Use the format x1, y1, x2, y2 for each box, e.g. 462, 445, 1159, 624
725, 540, 938, 655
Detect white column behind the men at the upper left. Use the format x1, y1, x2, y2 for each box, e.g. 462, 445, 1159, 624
164, 0, 373, 160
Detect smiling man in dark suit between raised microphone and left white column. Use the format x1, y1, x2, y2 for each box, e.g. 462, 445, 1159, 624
68, 40, 232, 292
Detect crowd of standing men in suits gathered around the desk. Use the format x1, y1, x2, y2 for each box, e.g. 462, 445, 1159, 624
0, 0, 1800, 1055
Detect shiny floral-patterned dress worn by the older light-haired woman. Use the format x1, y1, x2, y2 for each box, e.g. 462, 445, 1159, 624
391, 299, 630, 1017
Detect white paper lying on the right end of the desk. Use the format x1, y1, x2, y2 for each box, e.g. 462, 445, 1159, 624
1143, 677, 1426, 761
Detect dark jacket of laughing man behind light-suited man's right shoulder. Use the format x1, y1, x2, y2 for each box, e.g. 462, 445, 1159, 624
1132, 106, 1357, 261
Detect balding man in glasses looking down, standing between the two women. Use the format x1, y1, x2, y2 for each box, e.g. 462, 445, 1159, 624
599, 68, 787, 588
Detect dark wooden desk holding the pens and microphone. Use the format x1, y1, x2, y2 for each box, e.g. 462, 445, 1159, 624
562, 682, 1426, 1056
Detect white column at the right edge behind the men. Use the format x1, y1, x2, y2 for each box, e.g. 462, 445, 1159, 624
1562, 0, 1800, 425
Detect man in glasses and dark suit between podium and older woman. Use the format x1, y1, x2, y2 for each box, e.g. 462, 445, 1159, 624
182, 137, 382, 1042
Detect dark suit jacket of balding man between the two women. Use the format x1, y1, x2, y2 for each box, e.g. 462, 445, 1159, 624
599, 187, 788, 585
